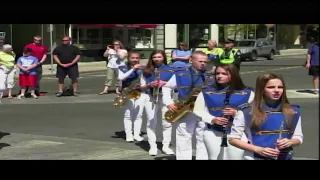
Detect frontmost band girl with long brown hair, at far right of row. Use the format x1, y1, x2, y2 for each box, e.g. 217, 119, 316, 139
229, 73, 303, 160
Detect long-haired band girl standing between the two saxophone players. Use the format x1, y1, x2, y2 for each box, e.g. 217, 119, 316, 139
141, 50, 174, 156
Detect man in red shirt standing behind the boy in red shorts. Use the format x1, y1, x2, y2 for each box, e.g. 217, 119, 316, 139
24, 35, 48, 96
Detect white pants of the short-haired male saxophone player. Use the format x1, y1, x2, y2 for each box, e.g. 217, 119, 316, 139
176, 113, 208, 160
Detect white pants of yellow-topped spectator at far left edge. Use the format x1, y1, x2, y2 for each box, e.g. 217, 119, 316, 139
0, 65, 15, 92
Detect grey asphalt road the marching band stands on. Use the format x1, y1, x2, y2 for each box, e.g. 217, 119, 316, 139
0, 56, 319, 159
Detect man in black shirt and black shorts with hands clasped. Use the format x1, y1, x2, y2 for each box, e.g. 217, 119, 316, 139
52, 36, 81, 97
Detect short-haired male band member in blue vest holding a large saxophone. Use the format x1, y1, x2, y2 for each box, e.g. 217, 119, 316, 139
162, 51, 208, 160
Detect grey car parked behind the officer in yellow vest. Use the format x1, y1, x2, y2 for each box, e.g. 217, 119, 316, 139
235, 39, 276, 61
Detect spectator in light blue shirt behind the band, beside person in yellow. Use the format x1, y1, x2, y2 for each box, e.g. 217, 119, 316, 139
171, 42, 192, 67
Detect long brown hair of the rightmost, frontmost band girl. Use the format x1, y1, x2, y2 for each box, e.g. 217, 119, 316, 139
251, 73, 295, 130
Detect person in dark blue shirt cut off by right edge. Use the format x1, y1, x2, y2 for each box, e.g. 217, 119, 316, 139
306, 38, 320, 94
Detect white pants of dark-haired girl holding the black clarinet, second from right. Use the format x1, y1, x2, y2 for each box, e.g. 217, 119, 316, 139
204, 128, 248, 160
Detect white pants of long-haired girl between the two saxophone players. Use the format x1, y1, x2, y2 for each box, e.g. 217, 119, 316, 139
144, 94, 172, 147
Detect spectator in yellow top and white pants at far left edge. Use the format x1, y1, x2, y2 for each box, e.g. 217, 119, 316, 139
0, 44, 15, 97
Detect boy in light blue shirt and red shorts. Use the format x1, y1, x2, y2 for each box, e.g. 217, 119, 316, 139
17, 48, 39, 99
